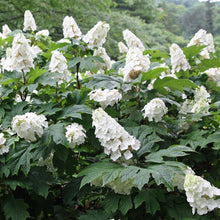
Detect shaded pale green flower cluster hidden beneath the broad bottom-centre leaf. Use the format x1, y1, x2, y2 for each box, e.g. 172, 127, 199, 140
91, 176, 137, 195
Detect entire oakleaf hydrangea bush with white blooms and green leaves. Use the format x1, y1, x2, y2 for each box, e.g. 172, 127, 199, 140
0, 6, 220, 220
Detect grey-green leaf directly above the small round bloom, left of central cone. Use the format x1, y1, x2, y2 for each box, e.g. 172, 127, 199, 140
59, 105, 92, 119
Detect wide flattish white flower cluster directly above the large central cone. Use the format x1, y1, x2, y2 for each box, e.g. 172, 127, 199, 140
89, 89, 122, 109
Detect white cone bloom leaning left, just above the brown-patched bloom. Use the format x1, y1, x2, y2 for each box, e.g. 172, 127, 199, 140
123, 29, 145, 52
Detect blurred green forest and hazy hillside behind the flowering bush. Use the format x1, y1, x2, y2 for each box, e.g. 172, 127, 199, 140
0, 0, 220, 58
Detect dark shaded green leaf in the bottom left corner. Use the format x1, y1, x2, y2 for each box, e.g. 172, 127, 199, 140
2, 196, 30, 220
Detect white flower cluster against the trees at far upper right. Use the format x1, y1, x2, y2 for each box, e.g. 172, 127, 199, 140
187, 29, 215, 59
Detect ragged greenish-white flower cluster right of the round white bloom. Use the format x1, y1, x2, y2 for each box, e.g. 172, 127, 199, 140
180, 86, 211, 114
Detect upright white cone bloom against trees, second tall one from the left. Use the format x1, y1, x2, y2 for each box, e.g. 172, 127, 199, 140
63, 16, 82, 39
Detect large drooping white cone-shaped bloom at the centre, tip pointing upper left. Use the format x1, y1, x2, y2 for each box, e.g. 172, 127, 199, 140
92, 108, 140, 161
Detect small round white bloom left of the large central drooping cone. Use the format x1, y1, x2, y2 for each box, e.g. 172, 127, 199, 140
66, 123, 86, 148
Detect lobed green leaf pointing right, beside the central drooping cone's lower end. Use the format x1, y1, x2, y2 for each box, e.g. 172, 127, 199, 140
145, 145, 193, 163
